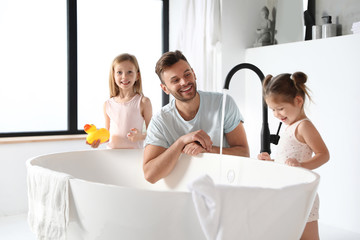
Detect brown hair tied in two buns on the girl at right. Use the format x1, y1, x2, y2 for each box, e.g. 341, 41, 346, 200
263, 72, 311, 103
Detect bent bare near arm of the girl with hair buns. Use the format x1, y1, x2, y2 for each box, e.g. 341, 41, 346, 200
295, 121, 330, 170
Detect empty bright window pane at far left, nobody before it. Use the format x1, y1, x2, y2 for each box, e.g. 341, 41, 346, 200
0, 0, 67, 133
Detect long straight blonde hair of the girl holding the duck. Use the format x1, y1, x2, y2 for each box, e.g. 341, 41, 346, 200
109, 53, 143, 98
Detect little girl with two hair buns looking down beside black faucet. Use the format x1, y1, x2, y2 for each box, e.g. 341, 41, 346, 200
258, 72, 330, 240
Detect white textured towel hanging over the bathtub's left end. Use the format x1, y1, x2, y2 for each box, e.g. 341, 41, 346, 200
27, 164, 71, 240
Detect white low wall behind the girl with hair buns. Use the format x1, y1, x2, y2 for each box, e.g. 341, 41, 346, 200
246, 34, 360, 233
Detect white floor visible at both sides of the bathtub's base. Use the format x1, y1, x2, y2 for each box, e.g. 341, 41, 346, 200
0, 214, 360, 240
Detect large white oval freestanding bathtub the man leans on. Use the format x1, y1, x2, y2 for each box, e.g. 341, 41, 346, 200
28, 149, 319, 240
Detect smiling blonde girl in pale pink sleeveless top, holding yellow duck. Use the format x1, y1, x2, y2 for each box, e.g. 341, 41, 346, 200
91, 53, 152, 148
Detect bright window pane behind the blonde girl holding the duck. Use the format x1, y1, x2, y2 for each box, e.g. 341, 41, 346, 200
77, 0, 163, 129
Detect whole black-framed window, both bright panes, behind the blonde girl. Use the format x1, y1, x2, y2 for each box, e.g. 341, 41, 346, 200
0, 0, 168, 137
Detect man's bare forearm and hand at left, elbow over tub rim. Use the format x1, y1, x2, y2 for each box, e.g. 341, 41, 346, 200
143, 130, 212, 183
